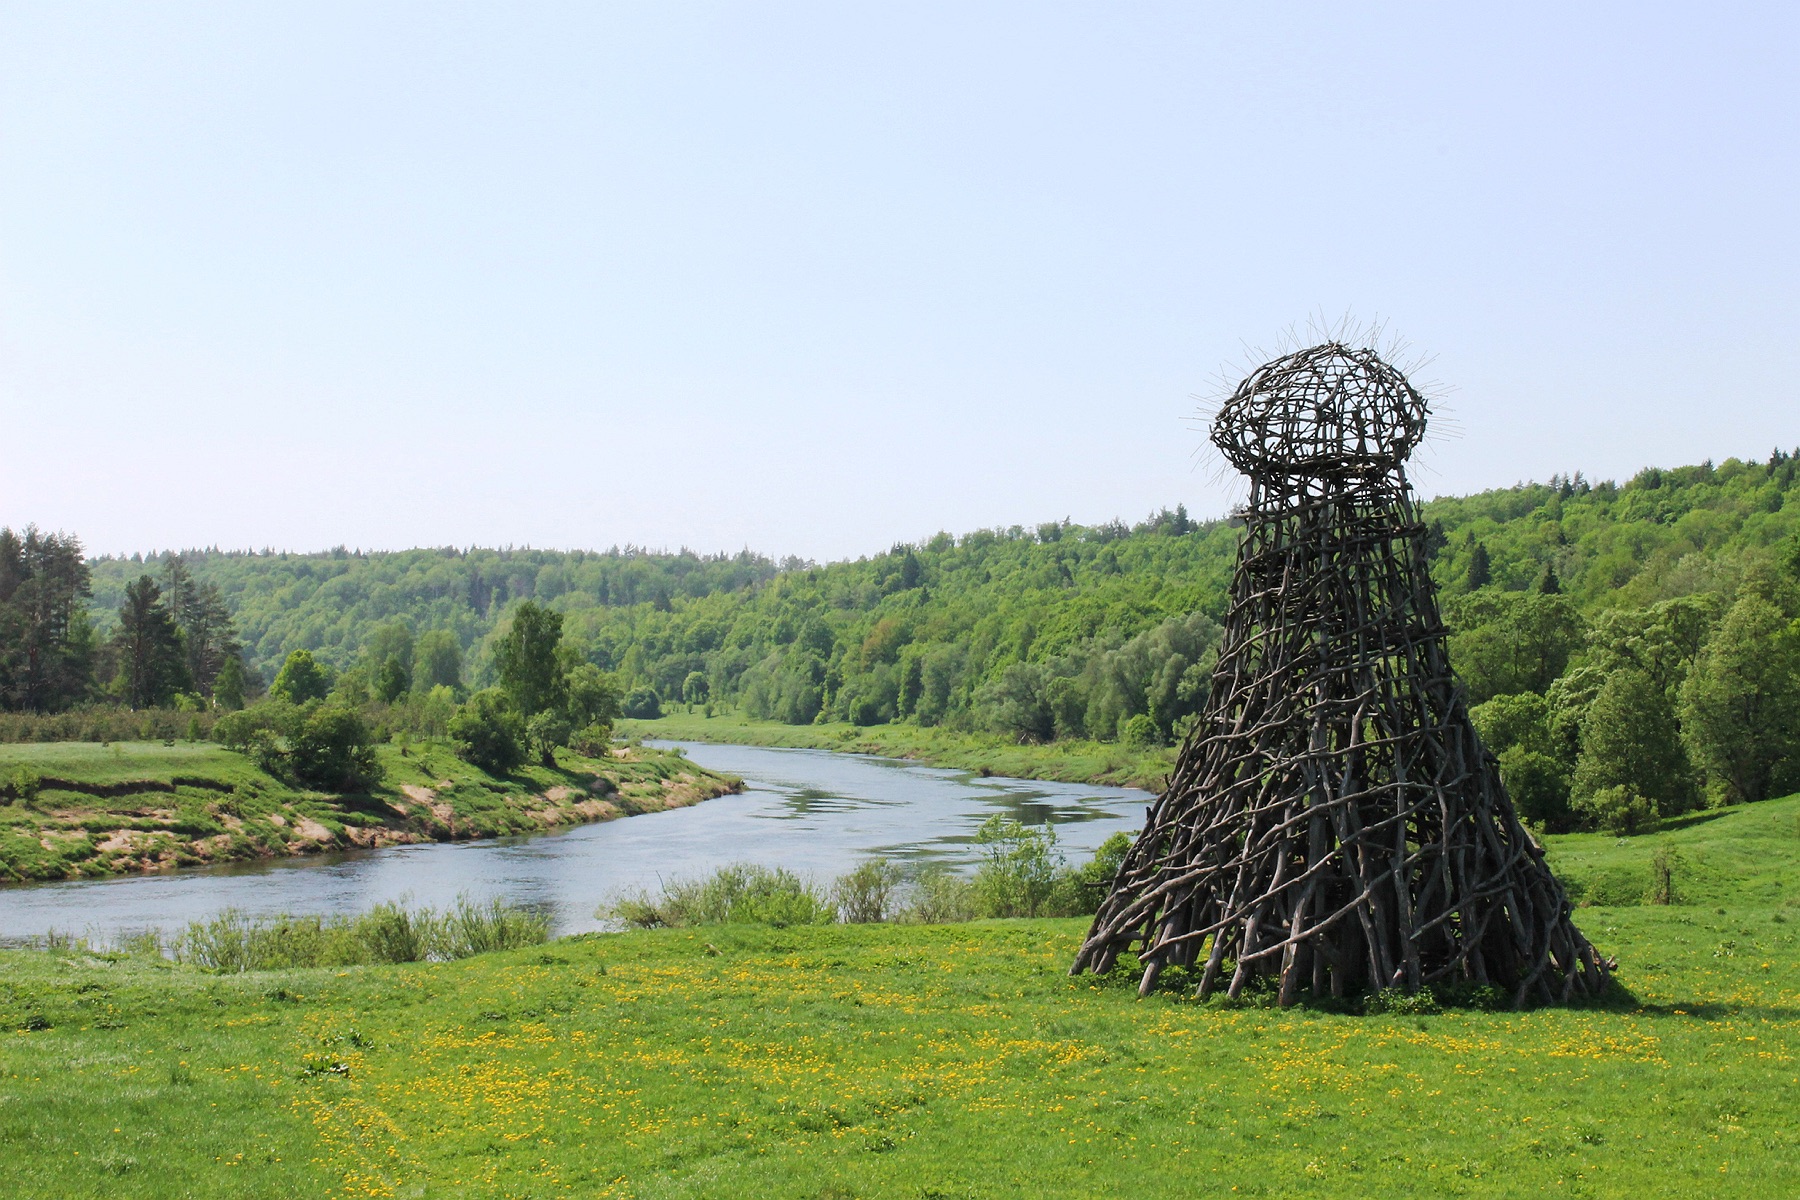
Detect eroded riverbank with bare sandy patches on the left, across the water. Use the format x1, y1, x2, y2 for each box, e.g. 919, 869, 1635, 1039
0, 741, 742, 882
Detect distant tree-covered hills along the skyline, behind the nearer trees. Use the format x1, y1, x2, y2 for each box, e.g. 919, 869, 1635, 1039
77, 453, 1800, 738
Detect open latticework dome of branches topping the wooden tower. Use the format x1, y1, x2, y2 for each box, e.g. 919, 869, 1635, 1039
1213, 342, 1427, 477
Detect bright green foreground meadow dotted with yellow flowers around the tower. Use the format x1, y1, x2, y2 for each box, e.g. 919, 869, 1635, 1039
0, 797, 1800, 1198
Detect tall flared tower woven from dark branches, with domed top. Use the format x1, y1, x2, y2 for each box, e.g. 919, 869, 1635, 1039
1073, 342, 1611, 1007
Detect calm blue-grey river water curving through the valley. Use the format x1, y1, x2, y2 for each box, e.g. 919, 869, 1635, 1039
0, 741, 1152, 943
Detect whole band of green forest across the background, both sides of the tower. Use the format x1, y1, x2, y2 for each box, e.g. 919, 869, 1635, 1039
0, 452, 1800, 833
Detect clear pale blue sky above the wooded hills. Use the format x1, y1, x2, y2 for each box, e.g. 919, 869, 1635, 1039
0, 0, 1800, 560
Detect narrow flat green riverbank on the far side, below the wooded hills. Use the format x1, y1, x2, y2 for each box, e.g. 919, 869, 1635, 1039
619, 712, 1175, 792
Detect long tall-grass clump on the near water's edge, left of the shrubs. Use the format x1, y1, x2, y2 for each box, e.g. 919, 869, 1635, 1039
169, 896, 549, 973
